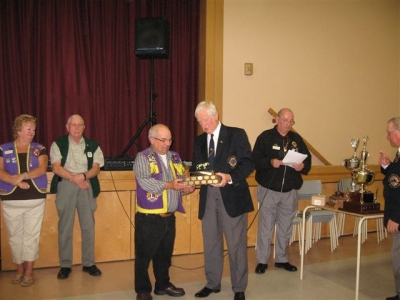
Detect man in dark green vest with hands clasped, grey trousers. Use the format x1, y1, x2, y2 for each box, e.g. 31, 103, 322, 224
50, 115, 104, 279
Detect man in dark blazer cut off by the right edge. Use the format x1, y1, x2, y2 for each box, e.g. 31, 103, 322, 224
379, 117, 400, 300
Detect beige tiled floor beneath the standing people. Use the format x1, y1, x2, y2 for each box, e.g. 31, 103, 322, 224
0, 233, 395, 300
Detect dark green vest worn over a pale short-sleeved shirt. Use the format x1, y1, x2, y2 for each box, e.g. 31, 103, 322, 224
50, 135, 100, 198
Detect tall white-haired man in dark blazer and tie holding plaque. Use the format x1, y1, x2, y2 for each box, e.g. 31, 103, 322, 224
191, 101, 254, 300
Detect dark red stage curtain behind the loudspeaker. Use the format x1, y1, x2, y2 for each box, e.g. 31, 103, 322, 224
0, 0, 199, 160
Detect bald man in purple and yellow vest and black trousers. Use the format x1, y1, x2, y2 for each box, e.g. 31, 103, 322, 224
133, 124, 194, 300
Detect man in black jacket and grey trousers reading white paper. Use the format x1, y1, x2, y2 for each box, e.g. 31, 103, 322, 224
252, 108, 311, 274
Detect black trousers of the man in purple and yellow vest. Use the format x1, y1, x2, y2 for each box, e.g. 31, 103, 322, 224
135, 213, 175, 293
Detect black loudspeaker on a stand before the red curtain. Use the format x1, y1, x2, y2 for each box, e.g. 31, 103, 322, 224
135, 17, 169, 59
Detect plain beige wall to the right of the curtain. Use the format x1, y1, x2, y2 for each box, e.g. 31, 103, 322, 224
220, 0, 399, 165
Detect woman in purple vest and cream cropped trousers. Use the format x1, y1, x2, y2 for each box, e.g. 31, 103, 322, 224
0, 115, 48, 287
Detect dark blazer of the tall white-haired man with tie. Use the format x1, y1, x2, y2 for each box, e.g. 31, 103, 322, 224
191, 124, 254, 220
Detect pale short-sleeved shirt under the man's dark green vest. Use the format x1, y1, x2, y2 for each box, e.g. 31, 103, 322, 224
50, 136, 104, 174
